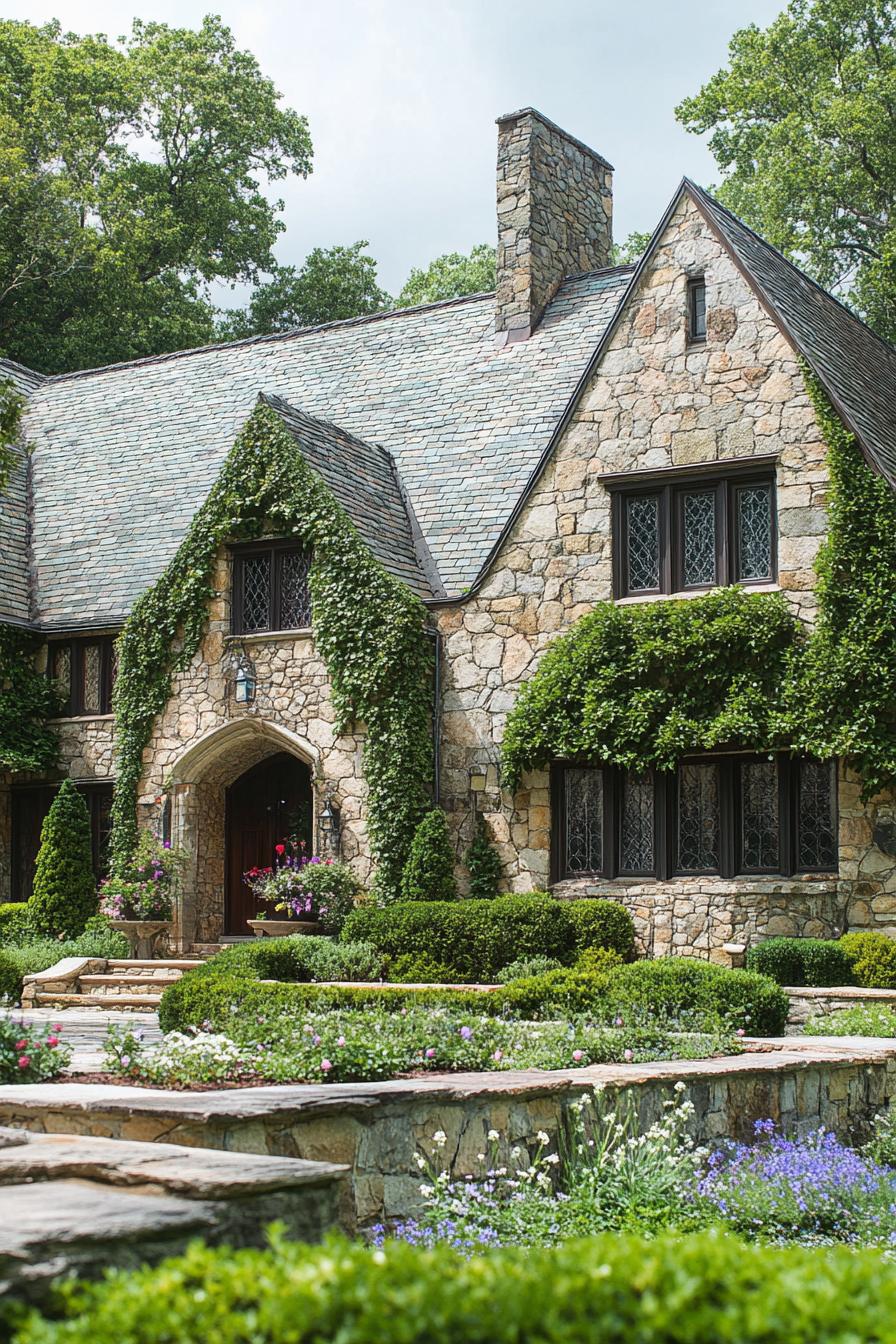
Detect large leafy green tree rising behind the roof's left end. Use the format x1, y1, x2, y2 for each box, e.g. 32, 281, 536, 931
0, 16, 312, 372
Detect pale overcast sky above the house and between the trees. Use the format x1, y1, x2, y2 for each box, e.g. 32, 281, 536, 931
3, 0, 785, 302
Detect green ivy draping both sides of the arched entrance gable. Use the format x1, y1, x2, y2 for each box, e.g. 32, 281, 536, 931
111, 403, 433, 899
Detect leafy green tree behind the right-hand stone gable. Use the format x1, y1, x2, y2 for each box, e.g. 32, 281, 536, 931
676, 0, 896, 340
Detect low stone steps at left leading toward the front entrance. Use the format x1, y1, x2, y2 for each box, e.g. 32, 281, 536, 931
21, 957, 200, 1011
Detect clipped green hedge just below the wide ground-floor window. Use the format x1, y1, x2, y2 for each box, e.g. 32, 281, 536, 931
341, 892, 634, 981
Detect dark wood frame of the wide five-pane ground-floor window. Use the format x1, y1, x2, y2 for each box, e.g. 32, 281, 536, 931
551, 753, 838, 883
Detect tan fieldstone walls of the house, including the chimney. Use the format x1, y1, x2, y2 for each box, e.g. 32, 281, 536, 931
10, 144, 896, 958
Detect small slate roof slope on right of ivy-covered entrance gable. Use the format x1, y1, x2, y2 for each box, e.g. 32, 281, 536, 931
261, 394, 433, 597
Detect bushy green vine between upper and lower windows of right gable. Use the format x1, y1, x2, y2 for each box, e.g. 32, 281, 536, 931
502, 587, 803, 788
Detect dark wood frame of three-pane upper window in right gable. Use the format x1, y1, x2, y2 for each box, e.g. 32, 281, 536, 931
600, 457, 778, 599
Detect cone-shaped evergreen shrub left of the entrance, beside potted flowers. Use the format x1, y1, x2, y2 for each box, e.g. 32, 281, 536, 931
28, 780, 98, 938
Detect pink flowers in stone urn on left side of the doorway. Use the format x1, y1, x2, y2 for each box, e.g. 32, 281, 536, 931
99, 831, 181, 961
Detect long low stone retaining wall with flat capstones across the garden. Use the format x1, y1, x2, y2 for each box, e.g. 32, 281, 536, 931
0, 1038, 896, 1227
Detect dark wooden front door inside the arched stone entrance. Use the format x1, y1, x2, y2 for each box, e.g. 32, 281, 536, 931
224, 751, 313, 935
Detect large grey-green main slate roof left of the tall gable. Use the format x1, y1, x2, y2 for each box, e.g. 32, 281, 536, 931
14, 267, 630, 629
